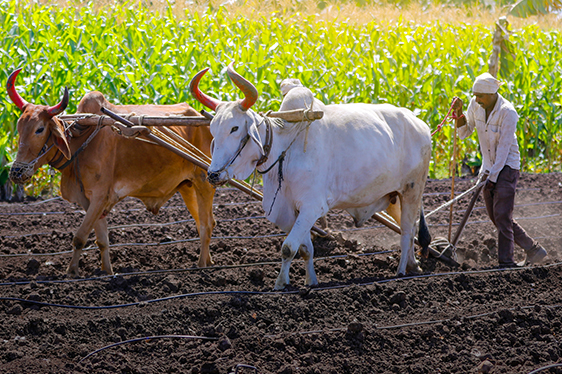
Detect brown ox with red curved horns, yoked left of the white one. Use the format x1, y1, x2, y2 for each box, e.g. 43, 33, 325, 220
7, 69, 215, 275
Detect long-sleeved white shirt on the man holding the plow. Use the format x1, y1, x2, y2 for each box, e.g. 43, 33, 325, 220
458, 94, 521, 183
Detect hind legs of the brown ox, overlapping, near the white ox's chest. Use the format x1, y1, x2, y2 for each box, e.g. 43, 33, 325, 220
179, 181, 216, 268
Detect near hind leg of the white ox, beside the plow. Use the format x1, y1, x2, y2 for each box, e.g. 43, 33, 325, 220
397, 198, 422, 276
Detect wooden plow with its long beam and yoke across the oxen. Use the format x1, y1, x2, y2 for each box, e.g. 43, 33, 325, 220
58, 108, 476, 267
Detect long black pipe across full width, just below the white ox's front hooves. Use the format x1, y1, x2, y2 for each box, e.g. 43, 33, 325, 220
4, 262, 562, 310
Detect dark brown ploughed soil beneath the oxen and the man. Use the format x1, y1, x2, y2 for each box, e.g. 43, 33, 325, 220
0, 173, 562, 374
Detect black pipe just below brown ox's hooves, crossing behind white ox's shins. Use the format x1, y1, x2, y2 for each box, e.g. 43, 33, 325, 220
0, 250, 395, 286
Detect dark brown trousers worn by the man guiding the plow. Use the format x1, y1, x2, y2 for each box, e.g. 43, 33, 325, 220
484, 166, 535, 263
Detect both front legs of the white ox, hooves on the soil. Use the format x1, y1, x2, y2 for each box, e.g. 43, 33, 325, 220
274, 213, 321, 290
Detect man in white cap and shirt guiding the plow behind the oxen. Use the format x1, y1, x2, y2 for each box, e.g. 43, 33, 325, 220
453, 73, 546, 267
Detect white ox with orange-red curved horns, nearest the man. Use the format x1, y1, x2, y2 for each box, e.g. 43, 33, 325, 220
190, 64, 431, 289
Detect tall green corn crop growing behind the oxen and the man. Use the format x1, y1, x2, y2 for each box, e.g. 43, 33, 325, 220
0, 0, 562, 195
